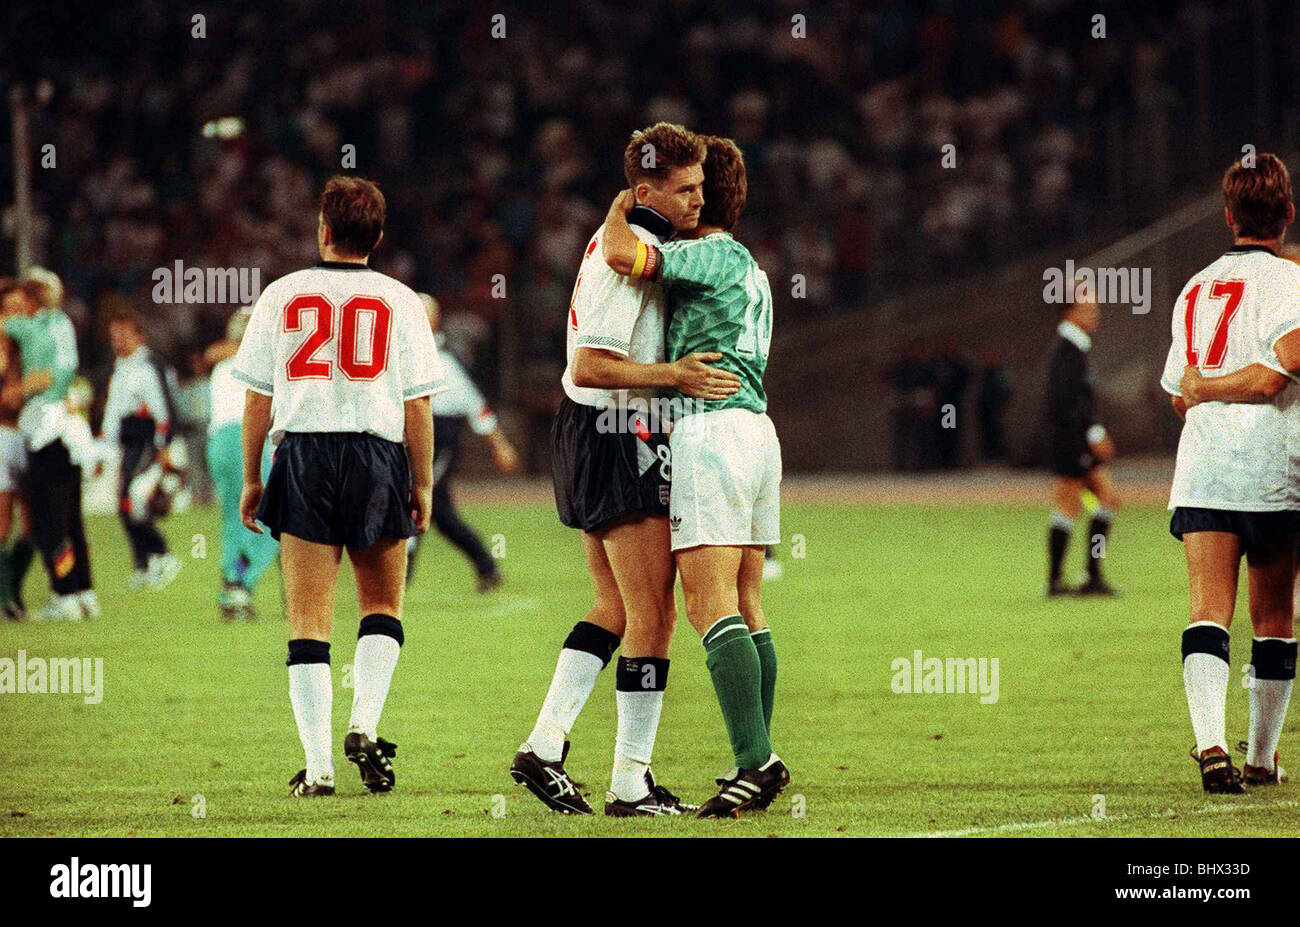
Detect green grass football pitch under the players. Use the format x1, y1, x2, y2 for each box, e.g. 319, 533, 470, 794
0, 491, 1300, 836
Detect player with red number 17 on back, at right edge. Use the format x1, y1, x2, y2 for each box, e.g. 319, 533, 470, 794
1161, 153, 1300, 793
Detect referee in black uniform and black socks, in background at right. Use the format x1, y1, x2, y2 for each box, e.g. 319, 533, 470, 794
1047, 299, 1119, 597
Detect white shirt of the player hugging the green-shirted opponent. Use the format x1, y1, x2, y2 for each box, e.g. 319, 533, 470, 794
560, 213, 667, 407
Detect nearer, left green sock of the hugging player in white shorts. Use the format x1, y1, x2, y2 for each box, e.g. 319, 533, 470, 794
703, 615, 772, 770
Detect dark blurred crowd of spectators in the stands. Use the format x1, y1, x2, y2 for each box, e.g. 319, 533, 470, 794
0, 0, 1274, 463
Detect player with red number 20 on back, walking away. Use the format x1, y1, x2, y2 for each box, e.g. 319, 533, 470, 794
233, 177, 442, 796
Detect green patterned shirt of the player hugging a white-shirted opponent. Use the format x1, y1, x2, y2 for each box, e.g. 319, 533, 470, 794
657, 231, 772, 412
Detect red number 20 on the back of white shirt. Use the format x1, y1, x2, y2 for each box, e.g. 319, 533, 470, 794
285, 293, 393, 380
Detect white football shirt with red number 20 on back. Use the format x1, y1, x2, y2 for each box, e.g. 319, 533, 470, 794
231, 261, 442, 445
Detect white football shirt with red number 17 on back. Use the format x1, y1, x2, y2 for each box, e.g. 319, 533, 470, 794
1160, 246, 1300, 512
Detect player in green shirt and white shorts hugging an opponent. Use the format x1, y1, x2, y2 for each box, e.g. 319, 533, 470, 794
602, 137, 790, 818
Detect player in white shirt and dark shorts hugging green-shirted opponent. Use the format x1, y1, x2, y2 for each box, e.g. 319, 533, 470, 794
510, 122, 740, 816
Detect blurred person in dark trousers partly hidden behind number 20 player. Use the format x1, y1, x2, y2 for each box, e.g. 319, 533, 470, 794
407, 293, 519, 593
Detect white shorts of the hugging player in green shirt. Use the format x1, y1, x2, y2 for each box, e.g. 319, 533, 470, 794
668, 408, 781, 550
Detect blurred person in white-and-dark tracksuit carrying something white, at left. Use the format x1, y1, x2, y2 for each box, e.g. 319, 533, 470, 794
103, 313, 181, 589
